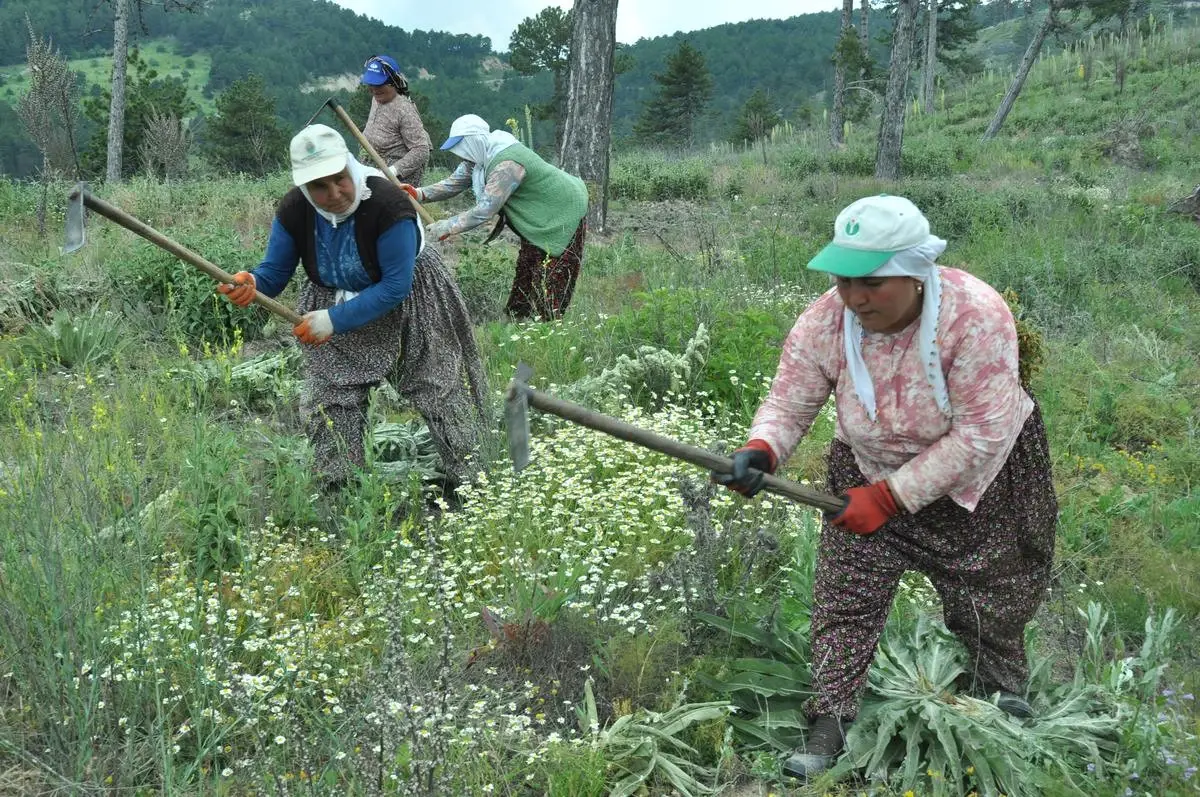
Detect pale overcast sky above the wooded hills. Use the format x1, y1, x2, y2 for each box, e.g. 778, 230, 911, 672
335, 0, 840, 52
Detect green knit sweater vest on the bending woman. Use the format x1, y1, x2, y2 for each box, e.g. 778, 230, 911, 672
487, 144, 588, 257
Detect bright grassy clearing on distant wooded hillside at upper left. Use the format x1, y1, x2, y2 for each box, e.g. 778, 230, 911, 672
0, 38, 216, 115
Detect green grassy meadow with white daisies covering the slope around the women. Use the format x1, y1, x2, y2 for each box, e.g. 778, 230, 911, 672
0, 18, 1200, 797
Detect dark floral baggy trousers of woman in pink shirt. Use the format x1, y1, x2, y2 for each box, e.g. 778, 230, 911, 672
804, 407, 1058, 719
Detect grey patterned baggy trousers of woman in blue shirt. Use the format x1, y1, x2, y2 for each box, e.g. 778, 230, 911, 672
299, 244, 487, 484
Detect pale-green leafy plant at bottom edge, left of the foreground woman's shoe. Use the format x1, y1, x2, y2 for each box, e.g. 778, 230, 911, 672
577, 678, 730, 797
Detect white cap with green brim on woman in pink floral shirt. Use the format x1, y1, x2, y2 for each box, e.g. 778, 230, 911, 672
809, 193, 929, 277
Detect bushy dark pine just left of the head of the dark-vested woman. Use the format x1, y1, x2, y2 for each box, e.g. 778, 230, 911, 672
204, 74, 288, 176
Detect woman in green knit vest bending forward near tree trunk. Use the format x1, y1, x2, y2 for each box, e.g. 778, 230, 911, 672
404, 114, 588, 320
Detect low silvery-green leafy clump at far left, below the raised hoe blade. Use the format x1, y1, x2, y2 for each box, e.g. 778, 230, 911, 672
17, 307, 127, 368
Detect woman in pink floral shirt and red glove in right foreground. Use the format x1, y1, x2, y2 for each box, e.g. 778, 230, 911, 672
714, 196, 1057, 777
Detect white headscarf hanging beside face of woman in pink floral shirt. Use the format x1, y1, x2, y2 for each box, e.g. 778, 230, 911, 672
842, 235, 950, 420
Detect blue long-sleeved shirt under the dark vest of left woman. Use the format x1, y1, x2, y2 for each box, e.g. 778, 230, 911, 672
252, 215, 418, 332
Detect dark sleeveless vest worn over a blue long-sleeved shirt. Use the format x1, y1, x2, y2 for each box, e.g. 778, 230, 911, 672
275, 176, 419, 288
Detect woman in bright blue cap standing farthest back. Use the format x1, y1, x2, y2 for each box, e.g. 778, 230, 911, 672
362, 55, 432, 185
